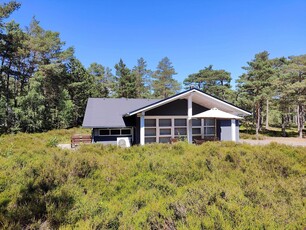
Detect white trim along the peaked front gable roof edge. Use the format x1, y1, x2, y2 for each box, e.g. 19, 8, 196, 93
126, 89, 251, 116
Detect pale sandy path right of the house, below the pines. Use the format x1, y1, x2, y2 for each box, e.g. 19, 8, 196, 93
239, 137, 306, 147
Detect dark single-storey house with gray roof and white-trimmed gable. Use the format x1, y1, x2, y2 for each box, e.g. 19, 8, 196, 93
83, 89, 251, 145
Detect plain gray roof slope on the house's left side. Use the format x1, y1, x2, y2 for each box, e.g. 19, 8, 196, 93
83, 98, 160, 128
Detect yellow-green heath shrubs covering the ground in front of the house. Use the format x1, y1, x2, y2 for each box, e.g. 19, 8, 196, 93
0, 129, 306, 229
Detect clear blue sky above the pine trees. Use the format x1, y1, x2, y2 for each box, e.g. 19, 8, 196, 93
8, 0, 306, 88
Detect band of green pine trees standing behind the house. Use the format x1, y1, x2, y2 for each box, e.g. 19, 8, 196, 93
0, 1, 306, 137
